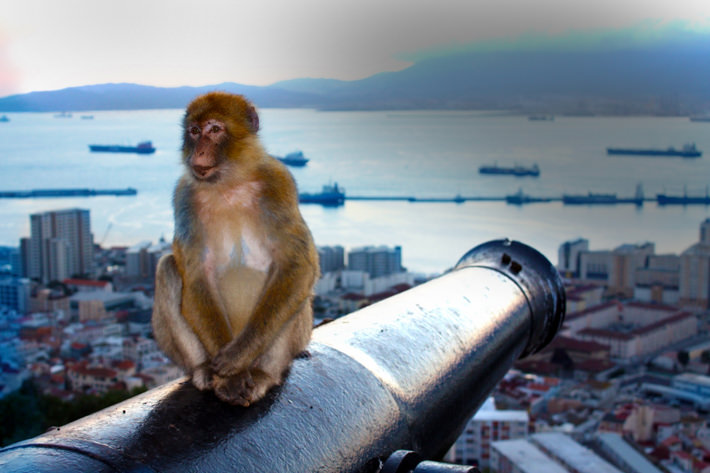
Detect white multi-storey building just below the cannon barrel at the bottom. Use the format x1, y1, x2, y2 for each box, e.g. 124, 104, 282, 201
452, 398, 530, 468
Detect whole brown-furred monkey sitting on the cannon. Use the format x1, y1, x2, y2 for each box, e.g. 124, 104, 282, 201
153, 92, 318, 406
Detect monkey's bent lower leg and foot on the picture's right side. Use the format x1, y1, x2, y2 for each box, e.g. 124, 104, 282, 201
214, 300, 313, 406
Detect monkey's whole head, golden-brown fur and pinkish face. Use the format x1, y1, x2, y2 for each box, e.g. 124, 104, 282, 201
182, 92, 259, 182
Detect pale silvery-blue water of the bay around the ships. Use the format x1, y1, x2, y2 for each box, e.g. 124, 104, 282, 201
0, 109, 710, 273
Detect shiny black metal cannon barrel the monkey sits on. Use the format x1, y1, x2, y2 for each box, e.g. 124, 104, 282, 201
0, 240, 565, 473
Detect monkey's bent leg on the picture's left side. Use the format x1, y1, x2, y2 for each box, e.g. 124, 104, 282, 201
152, 254, 212, 390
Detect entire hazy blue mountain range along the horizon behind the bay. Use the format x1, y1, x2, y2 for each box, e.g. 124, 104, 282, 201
0, 34, 710, 115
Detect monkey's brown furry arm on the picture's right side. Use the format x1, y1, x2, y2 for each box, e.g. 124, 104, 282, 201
212, 166, 318, 376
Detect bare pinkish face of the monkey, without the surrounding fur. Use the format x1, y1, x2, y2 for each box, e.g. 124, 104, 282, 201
185, 118, 228, 181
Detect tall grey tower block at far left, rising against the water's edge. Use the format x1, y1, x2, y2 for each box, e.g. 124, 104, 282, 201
27, 209, 94, 283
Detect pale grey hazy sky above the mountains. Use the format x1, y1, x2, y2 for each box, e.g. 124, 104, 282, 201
0, 0, 710, 96
